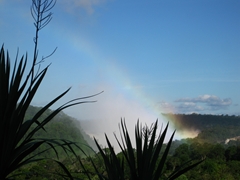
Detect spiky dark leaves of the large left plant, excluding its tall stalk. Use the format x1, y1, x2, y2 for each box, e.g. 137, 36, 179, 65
0, 47, 97, 179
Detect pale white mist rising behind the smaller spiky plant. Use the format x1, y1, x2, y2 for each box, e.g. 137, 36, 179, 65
62, 86, 177, 151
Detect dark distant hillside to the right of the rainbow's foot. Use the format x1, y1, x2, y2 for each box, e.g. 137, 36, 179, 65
163, 114, 240, 144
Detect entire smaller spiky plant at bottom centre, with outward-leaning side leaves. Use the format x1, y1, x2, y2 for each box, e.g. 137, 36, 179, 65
82, 120, 202, 180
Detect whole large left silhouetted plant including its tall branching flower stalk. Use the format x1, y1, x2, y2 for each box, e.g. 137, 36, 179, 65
0, 0, 98, 179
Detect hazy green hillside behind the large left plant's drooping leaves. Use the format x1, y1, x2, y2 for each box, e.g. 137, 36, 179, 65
25, 106, 94, 157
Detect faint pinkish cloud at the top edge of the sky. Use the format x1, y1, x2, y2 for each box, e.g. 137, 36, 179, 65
61, 0, 106, 15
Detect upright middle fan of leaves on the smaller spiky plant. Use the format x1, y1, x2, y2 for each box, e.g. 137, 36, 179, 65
116, 121, 174, 179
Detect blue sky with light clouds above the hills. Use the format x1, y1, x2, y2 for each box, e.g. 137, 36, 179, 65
0, 0, 240, 139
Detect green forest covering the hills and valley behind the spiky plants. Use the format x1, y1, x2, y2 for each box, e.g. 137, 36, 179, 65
9, 106, 240, 180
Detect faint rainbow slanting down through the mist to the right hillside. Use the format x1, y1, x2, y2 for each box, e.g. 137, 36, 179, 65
54, 30, 198, 139
